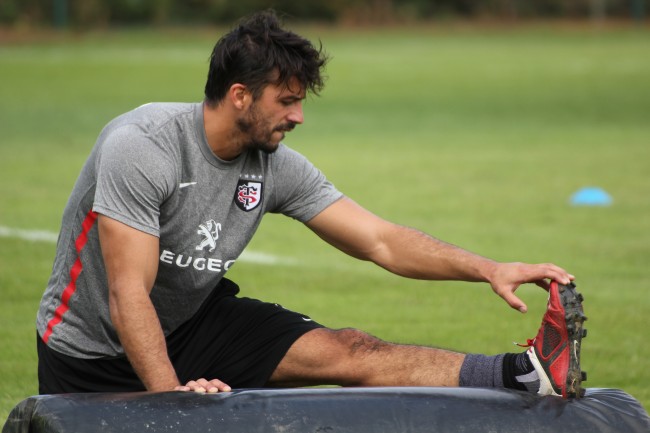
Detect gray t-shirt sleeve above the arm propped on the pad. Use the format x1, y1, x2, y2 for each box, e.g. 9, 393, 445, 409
93, 125, 177, 236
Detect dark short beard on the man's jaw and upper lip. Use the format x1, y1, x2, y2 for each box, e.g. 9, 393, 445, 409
236, 104, 296, 154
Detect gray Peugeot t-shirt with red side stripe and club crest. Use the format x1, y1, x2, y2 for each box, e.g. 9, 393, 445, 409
36, 103, 342, 358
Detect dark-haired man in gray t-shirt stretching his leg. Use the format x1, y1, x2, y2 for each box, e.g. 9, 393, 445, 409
37, 12, 584, 397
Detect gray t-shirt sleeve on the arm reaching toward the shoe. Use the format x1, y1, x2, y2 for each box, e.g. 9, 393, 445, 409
271, 146, 343, 223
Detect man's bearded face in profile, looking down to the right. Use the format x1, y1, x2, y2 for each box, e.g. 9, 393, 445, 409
237, 79, 305, 153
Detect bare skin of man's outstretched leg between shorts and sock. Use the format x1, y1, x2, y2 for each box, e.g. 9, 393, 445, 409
269, 329, 465, 387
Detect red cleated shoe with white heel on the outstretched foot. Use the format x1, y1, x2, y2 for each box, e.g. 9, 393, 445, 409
527, 281, 587, 398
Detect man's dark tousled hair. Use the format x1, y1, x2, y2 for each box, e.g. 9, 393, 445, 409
205, 10, 327, 105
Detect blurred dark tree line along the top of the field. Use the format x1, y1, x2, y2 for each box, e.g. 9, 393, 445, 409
0, 0, 650, 27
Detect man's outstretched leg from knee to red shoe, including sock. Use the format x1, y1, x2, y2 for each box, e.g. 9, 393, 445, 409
269, 281, 586, 398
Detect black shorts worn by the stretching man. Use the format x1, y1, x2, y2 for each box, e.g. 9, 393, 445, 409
37, 278, 323, 394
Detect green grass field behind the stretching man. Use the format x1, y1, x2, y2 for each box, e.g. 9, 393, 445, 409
0, 22, 650, 422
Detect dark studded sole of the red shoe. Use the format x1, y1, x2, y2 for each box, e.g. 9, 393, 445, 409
558, 283, 587, 398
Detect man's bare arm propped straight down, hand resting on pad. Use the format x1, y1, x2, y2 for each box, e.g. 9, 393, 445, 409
99, 215, 230, 392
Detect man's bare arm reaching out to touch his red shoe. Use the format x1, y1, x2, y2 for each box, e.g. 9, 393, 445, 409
307, 198, 573, 312
